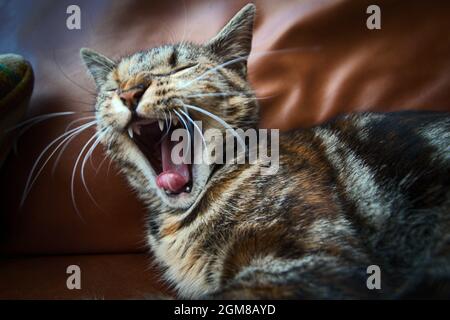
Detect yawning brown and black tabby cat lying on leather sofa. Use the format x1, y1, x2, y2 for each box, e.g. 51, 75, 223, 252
81, 4, 450, 299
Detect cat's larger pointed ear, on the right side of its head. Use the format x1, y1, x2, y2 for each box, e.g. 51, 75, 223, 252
207, 3, 256, 61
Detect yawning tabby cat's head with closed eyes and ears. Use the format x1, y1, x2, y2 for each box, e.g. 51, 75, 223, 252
81, 4, 258, 208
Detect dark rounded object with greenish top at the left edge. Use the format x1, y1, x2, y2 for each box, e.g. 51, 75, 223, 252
0, 54, 34, 166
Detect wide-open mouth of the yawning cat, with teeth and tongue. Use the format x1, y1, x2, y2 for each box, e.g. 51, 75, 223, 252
128, 118, 193, 196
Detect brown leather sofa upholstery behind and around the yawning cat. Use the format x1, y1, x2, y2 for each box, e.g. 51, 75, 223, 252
0, 0, 450, 298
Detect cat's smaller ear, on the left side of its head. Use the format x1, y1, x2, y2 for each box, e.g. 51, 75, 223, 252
80, 48, 116, 87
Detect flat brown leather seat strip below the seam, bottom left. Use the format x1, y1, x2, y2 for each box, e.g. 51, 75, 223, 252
0, 254, 167, 299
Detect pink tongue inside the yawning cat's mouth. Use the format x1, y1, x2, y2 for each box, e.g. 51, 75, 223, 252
156, 137, 190, 192
